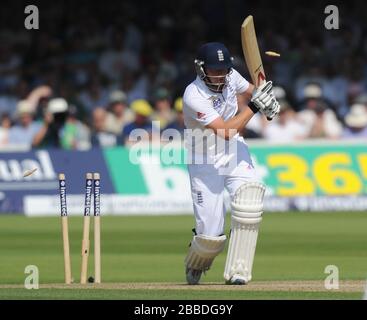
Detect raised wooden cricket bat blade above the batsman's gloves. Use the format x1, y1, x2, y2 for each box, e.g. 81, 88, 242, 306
241, 16, 266, 87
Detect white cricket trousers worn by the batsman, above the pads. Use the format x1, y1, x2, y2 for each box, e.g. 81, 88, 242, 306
188, 138, 259, 236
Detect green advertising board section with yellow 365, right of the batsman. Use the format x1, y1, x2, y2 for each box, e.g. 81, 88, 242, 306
250, 144, 367, 197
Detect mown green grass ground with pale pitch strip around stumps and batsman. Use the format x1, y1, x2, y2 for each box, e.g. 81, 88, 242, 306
0, 213, 367, 299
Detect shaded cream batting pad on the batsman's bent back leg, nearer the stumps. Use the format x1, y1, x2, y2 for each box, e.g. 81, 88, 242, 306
185, 235, 227, 271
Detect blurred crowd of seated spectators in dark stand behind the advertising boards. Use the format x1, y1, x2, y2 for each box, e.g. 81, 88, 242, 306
0, 0, 367, 150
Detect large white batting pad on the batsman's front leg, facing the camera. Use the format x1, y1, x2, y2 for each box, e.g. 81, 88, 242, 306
224, 182, 265, 283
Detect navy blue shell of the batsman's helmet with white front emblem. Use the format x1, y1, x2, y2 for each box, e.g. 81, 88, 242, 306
197, 42, 233, 70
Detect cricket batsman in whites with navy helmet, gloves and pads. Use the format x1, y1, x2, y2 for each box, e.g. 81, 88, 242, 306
183, 42, 279, 285
